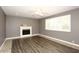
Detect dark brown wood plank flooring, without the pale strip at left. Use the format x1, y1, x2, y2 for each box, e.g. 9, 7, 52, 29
11, 36, 79, 53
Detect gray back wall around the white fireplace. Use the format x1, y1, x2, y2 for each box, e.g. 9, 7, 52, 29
6, 16, 39, 38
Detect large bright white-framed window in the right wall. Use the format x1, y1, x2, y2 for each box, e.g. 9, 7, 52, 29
45, 15, 71, 32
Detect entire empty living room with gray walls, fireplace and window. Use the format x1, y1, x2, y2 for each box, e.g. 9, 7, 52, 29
0, 6, 79, 53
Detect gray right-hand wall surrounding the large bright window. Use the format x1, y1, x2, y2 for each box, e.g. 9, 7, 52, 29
40, 9, 79, 44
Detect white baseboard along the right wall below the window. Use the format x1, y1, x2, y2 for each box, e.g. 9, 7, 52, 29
39, 34, 79, 50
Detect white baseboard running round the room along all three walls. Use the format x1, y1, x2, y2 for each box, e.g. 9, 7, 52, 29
0, 34, 79, 50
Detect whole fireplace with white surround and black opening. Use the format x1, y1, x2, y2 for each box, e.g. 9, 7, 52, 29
20, 26, 32, 36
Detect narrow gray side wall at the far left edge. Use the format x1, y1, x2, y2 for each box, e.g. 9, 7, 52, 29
0, 7, 5, 46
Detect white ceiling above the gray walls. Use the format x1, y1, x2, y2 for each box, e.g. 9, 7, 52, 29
2, 6, 79, 19
